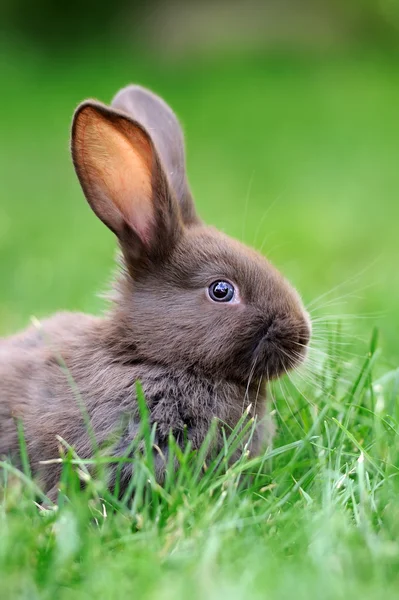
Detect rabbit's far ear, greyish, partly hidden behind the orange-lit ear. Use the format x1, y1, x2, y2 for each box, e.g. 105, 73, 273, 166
111, 85, 200, 226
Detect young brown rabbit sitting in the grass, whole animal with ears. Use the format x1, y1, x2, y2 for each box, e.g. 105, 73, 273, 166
0, 86, 310, 493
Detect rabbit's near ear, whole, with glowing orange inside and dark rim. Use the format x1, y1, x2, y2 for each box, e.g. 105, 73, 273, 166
72, 101, 182, 261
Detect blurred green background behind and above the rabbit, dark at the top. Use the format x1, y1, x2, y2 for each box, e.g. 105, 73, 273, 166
0, 0, 399, 365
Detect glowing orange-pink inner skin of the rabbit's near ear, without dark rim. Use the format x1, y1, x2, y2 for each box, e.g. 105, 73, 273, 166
81, 108, 155, 245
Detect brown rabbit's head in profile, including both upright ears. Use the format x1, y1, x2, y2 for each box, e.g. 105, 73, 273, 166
72, 86, 310, 383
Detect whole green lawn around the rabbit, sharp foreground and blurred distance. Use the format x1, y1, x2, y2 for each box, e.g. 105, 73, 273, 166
0, 47, 399, 600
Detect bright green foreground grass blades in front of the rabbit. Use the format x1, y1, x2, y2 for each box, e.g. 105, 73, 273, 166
0, 336, 399, 599
